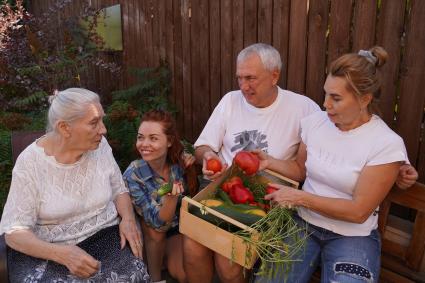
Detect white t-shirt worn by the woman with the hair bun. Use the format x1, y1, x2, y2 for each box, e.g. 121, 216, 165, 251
298, 111, 408, 236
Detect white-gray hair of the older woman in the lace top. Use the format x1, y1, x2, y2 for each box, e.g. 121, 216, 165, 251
46, 88, 100, 132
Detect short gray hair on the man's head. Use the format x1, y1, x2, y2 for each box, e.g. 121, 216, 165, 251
236, 43, 282, 72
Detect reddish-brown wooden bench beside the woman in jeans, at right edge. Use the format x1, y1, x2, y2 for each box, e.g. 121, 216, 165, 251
379, 183, 425, 282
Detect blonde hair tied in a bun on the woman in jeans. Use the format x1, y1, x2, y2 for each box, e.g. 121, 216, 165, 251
329, 46, 388, 113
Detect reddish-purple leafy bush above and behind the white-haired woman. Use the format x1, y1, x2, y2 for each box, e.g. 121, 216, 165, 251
0, 0, 121, 111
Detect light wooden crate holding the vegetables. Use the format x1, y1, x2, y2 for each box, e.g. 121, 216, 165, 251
179, 169, 298, 269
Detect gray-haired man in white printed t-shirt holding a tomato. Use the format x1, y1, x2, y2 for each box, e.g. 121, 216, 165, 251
184, 43, 417, 282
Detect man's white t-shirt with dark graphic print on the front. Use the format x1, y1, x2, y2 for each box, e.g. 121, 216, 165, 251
195, 87, 320, 165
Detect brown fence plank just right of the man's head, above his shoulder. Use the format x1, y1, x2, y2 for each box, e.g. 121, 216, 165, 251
287, 0, 307, 93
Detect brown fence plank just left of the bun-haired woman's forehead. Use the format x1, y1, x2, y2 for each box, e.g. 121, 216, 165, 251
306, 0, 329, 105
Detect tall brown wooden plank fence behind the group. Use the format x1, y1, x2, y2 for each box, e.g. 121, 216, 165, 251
31, 0, 425, 181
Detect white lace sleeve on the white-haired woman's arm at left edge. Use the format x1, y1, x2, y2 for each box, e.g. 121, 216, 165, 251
0, 155, 39, 234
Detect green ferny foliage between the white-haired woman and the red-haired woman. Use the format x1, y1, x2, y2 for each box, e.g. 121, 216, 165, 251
105, 64, 175, 170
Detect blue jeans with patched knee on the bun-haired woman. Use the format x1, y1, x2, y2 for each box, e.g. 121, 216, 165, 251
255, 216, 381, 283
